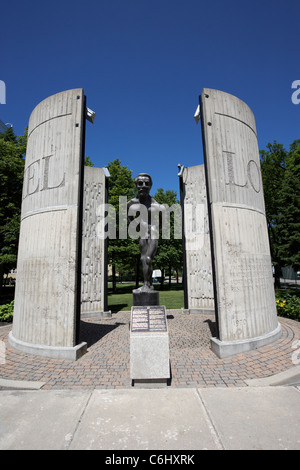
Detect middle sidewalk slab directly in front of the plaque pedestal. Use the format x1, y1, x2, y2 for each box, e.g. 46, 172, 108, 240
69, 388, 219, 450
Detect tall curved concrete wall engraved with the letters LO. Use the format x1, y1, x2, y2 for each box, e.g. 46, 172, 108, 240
200, 89, 280, 357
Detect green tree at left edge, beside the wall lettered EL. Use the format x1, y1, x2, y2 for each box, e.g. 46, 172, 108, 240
0, 128, 27, 292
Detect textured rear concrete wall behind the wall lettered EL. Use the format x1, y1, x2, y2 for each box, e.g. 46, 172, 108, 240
81, 167, 107, 316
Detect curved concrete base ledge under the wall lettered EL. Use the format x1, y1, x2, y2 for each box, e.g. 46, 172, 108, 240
8, 331, 87, 361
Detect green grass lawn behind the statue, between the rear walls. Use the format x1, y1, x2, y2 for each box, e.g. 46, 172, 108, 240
108, 284, 184, 312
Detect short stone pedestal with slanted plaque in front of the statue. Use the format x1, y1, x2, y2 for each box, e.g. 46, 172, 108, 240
130, 306, 170, 388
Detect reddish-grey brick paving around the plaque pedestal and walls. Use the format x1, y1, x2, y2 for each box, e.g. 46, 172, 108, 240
0, 311, 300, 389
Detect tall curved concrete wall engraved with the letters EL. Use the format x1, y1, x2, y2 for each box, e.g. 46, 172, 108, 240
10, 89, 86, 359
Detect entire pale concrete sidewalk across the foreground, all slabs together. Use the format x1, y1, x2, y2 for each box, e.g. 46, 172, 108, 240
0, 383, 300, 455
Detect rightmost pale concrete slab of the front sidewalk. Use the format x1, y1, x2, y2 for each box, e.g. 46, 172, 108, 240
200, 387, 300, 450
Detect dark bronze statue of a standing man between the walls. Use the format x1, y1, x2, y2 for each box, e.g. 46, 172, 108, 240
127, 173, 165, 292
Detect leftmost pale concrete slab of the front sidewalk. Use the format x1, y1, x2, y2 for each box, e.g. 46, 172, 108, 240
0, 390, 90, 450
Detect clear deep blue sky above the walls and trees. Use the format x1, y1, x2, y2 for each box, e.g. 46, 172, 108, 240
0, 0, 300, 194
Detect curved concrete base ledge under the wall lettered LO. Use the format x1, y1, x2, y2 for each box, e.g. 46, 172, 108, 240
211, 323, 281, 359
